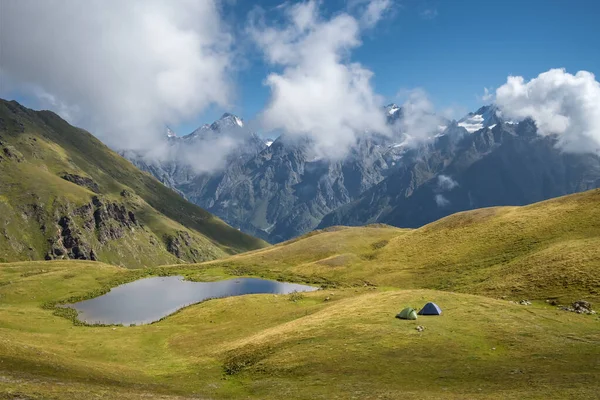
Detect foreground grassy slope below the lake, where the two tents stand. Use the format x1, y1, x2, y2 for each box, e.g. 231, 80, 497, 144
0, 261, 600, 399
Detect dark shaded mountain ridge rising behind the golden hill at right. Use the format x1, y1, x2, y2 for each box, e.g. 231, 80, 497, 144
319, 120, 600, 228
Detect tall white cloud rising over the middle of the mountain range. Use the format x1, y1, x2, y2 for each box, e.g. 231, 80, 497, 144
248, 0, 391, 158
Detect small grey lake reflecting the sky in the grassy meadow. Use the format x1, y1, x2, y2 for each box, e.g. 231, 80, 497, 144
67, 276, 318, 325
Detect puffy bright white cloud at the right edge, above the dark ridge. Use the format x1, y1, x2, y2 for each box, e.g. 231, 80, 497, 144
496, 69, 600, 152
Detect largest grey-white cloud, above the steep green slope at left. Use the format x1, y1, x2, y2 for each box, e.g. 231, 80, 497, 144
0, 0, 232, 149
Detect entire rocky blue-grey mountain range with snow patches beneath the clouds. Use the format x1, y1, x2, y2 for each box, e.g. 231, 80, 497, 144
125, 104, 600, 243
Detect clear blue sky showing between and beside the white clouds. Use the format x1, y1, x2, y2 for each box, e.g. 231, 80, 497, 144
175, 0, 600, 134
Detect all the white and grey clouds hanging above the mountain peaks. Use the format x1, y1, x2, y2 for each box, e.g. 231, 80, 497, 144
0, 0, 600, 171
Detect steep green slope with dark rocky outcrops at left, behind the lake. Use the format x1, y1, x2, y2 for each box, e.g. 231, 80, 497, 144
0, 100, 266, 267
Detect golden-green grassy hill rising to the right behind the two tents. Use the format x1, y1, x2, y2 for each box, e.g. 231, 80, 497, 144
198, 189, 600, 301
